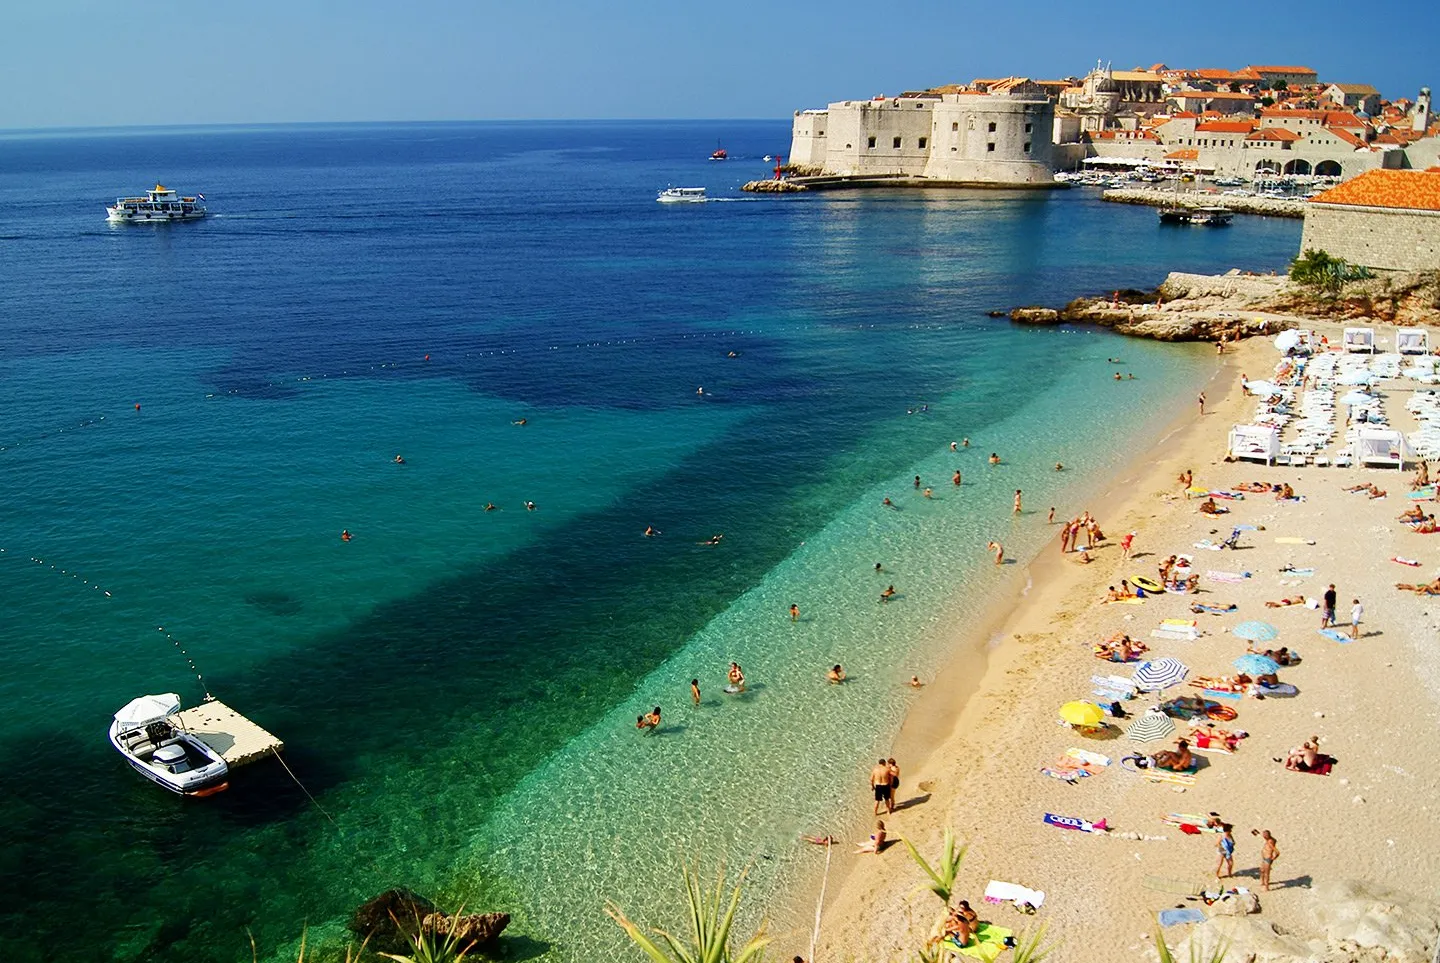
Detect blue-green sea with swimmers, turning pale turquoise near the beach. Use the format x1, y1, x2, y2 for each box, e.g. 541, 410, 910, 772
0, 119, 1300, 963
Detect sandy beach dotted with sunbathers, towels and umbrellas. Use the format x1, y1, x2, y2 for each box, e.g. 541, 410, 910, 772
779, 321, 1440, 963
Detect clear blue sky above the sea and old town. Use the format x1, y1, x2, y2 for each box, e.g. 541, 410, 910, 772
0, 0, 1440, 128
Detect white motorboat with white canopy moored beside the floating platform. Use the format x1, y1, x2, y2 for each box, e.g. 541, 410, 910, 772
109, 692, 230, 796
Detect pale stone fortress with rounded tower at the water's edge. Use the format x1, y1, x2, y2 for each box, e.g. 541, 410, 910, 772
791, 84, 1056, 187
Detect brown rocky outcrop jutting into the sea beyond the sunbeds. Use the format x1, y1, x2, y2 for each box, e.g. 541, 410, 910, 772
1008, 271, 1440, 341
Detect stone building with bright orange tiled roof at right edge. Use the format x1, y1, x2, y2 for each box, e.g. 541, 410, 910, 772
1300, 170, 1440, 271
